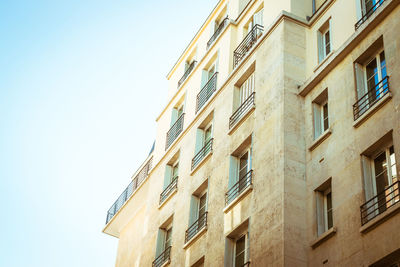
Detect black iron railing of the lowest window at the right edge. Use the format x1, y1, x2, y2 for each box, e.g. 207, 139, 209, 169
360, 181, 400, 225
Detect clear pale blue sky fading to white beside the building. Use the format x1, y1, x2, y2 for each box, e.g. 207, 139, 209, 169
0, 0, 217, 267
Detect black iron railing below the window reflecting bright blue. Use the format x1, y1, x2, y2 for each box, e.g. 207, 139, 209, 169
353, 76, 390, 120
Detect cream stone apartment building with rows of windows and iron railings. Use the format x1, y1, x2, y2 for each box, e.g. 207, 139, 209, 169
103, 0, 400, 267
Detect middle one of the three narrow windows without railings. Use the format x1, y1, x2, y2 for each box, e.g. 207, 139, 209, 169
312, 89, 329, 139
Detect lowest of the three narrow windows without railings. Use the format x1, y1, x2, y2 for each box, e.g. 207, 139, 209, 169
315, 179, 333, 236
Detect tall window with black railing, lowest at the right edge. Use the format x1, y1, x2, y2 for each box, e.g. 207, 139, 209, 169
361, 135, 400, 224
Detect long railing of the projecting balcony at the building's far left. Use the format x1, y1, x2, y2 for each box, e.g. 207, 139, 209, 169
106, 158, 153, 224
